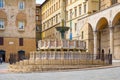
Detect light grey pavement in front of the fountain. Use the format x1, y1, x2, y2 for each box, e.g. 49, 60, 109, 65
0, 64, 120, 80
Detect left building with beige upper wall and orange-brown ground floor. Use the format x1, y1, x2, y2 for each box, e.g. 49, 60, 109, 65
0, 0, 36, 62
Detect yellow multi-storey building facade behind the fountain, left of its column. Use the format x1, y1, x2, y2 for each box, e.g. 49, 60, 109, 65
41, 0, 61, 39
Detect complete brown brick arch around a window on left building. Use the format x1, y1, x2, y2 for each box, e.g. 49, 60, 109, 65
16, 12, 27, 26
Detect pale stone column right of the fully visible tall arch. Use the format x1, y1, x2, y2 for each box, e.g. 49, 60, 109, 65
110, 27, 114, 54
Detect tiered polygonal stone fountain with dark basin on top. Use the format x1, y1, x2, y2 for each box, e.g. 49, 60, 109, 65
9, 0, 110, 72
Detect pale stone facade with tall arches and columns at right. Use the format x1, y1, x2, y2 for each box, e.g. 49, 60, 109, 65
77, 0, 120, 59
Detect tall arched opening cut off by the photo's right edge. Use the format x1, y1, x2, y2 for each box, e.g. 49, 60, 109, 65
112, 12, 120, 59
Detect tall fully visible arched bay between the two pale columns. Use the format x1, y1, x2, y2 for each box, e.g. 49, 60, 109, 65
96, 17, 110, 58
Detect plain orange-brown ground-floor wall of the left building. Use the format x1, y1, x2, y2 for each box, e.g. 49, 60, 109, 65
0, 38, 36, 62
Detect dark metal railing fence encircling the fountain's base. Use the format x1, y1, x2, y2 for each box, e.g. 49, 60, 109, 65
9, 52, 112, 66
